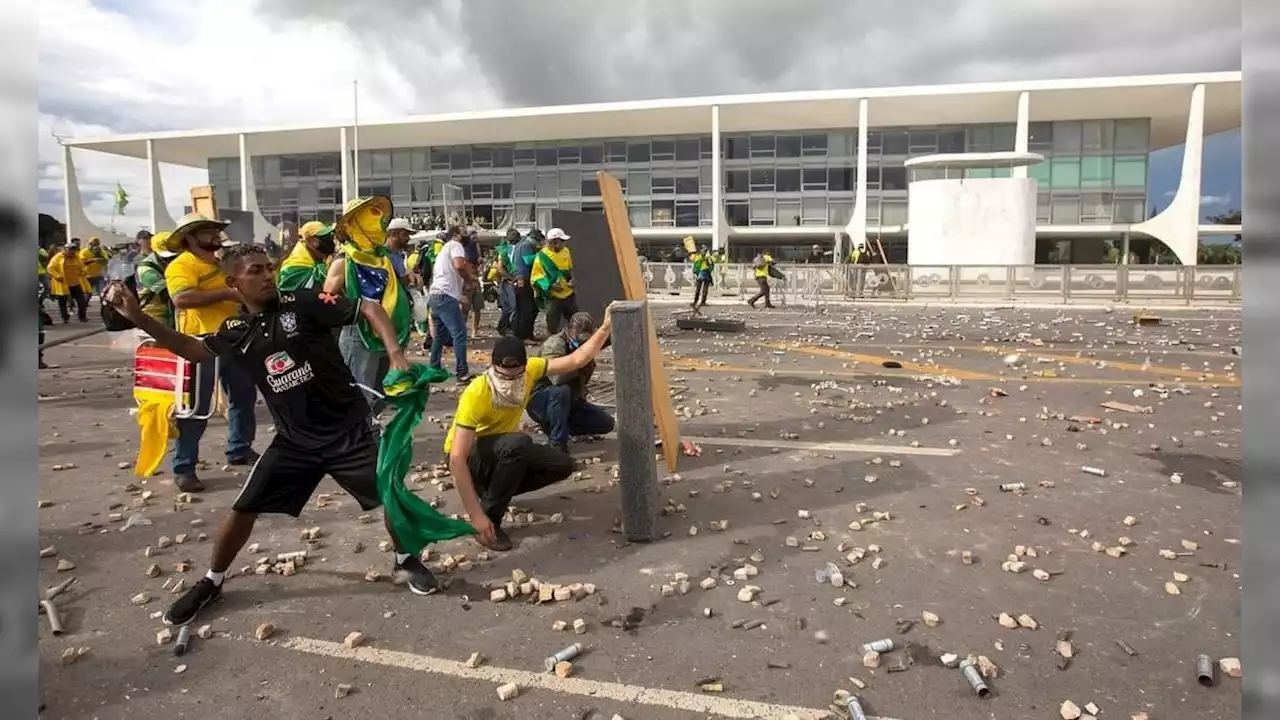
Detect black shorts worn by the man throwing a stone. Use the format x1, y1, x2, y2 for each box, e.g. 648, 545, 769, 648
232, 423, 383, 518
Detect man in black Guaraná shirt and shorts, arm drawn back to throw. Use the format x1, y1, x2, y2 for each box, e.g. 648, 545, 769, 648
108, 245, 448, 625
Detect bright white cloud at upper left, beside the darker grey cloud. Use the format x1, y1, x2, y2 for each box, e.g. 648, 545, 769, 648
38, 0, 497, 234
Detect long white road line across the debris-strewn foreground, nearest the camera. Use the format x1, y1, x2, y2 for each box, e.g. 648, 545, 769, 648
278, 638, 892, 720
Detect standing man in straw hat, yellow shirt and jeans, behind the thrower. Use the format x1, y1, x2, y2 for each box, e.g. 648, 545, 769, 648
164, 213, 259, 492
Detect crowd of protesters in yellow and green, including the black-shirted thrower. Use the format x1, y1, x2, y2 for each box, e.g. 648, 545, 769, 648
53, 197, 613, 625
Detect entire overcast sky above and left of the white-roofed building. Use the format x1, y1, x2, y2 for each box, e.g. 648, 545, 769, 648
38, 0, 1240, 233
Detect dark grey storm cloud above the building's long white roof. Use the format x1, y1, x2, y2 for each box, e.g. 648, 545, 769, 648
252, 0, 1242, 110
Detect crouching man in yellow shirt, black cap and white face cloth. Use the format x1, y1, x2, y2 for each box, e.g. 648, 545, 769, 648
444, 309, 612, 551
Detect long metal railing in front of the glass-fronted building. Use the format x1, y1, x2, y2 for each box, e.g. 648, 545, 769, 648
641, 261, 1242, 305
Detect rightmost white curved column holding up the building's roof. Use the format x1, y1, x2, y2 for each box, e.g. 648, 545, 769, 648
1133, 85, 1204, 265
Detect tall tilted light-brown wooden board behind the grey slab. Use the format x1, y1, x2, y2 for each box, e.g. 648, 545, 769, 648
595, 170, 680, 473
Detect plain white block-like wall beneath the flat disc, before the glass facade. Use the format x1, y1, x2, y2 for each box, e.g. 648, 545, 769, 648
906, 178, 1036, 265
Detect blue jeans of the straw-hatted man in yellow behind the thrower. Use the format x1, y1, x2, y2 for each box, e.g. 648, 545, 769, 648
173, 360, 257, 475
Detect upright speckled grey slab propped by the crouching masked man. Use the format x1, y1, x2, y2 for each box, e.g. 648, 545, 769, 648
612, 300, 662, 542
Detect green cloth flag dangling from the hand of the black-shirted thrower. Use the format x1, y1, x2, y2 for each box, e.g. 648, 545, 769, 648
378, 364, 475, 555
